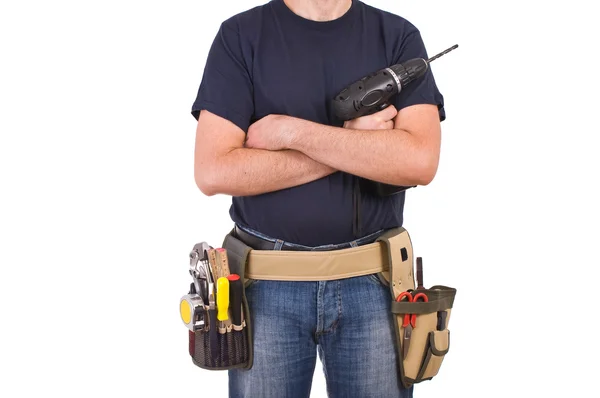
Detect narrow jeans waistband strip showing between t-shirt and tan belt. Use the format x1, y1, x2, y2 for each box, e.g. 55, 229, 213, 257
233, 225, 384, 251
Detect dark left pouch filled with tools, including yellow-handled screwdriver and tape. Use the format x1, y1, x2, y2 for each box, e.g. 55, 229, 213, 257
180, 239, 252, 370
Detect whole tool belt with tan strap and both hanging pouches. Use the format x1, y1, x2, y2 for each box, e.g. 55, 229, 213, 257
181, 228, 456, 387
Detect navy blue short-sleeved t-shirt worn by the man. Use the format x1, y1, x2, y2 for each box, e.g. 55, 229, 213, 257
192, 0, 445, 246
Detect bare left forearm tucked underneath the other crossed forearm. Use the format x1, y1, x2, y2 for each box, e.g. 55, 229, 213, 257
201, 148, 335, 196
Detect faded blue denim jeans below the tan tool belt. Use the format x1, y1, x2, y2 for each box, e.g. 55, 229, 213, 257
229, 227, 413, 398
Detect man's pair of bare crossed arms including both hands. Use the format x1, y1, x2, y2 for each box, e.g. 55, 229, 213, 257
194, 104, 441, 196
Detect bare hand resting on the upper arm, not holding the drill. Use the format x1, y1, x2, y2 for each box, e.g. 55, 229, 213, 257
246, 115, 296, 151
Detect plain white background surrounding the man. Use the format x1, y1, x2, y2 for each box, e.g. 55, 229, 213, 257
0, 0, 600, 397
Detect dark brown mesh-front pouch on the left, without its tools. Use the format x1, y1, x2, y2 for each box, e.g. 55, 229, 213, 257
189, 234, 253, 370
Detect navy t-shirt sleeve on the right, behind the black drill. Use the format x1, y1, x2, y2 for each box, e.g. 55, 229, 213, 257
394, 27, 446, 121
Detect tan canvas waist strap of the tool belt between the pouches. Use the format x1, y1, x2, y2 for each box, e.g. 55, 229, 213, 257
246, 242, 389, 281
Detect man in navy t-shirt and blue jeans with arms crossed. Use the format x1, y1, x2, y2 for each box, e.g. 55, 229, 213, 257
192, 0, 445, 398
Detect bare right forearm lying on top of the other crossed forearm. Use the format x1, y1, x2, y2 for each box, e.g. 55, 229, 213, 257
290, 120, 437, 185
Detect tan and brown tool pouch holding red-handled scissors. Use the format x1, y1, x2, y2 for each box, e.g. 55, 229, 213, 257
378, 228, 456, 387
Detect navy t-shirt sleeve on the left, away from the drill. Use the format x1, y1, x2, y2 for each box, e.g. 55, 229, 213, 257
192, 20, 254, 133
